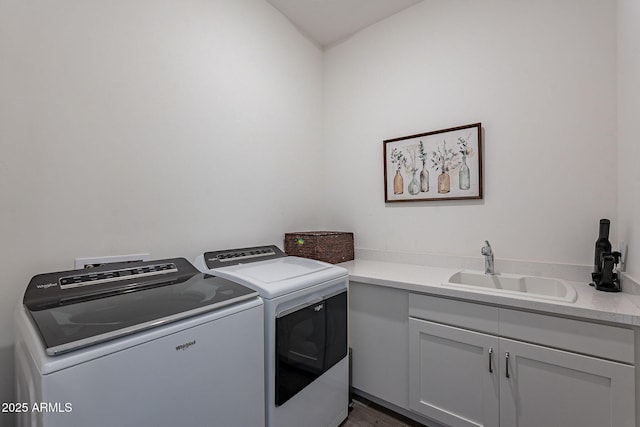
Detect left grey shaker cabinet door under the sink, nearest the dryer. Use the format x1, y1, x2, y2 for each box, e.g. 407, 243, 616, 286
409, 318, 500, 427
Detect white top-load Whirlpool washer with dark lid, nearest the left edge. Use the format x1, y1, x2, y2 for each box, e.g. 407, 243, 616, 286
15, 258, 265, 427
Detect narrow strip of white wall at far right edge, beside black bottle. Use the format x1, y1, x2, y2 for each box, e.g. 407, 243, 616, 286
618, 0, 640, 281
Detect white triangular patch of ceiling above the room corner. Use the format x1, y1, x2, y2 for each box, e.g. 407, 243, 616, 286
267, 0, 422, 47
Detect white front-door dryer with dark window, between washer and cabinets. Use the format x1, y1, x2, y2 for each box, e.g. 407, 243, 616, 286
194, 246, 349, 427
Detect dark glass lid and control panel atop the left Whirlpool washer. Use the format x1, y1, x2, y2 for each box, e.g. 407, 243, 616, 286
24, 258, 258, 356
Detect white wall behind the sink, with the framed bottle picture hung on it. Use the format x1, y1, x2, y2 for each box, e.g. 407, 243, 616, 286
325, 0, 618, 268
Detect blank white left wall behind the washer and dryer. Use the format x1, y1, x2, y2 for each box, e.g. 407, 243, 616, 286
0, 0, 322, 416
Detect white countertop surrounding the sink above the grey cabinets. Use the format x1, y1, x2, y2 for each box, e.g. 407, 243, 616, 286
340, 259, 640, 326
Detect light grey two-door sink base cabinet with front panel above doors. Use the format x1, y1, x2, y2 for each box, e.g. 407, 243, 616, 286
409, 294, 636, 427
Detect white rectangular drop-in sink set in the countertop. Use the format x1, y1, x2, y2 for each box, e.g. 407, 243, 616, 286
443, 270, 578, 302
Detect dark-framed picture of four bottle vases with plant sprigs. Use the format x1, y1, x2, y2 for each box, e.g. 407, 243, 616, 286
383, 123, 482, 203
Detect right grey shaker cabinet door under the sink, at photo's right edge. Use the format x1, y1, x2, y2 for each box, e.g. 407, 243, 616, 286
500, 339, 636, 427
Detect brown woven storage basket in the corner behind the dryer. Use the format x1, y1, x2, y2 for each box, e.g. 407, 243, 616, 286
284, 231, 353, 264
